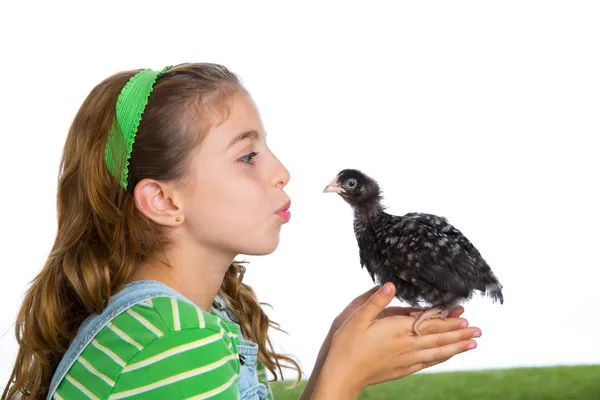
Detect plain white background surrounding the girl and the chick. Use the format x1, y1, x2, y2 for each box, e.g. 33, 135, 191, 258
0, 0, 600, 386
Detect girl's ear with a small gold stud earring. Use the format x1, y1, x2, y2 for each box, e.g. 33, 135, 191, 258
133, 179, 183, 226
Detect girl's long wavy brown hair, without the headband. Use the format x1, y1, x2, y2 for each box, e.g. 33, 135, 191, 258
2, 63, 301, 400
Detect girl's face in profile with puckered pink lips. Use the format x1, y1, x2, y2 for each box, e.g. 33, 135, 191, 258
181, 93, 290, 255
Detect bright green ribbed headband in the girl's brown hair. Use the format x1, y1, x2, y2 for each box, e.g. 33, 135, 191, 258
104, 66, 173, 189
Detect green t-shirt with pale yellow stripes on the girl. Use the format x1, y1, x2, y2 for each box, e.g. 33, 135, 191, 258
54, 297, 273, 400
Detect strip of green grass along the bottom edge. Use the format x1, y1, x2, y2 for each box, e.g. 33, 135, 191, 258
272, 365, 600, 400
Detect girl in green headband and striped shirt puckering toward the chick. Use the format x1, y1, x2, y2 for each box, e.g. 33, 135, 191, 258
2, 64, 480, 400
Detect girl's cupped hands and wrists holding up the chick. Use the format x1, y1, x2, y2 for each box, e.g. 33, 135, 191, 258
313, 283, 481, 400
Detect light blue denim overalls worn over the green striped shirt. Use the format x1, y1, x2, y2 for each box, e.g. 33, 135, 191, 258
46, 280, 267, 400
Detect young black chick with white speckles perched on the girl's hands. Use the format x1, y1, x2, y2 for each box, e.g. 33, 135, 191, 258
323, 169, 504, 335
